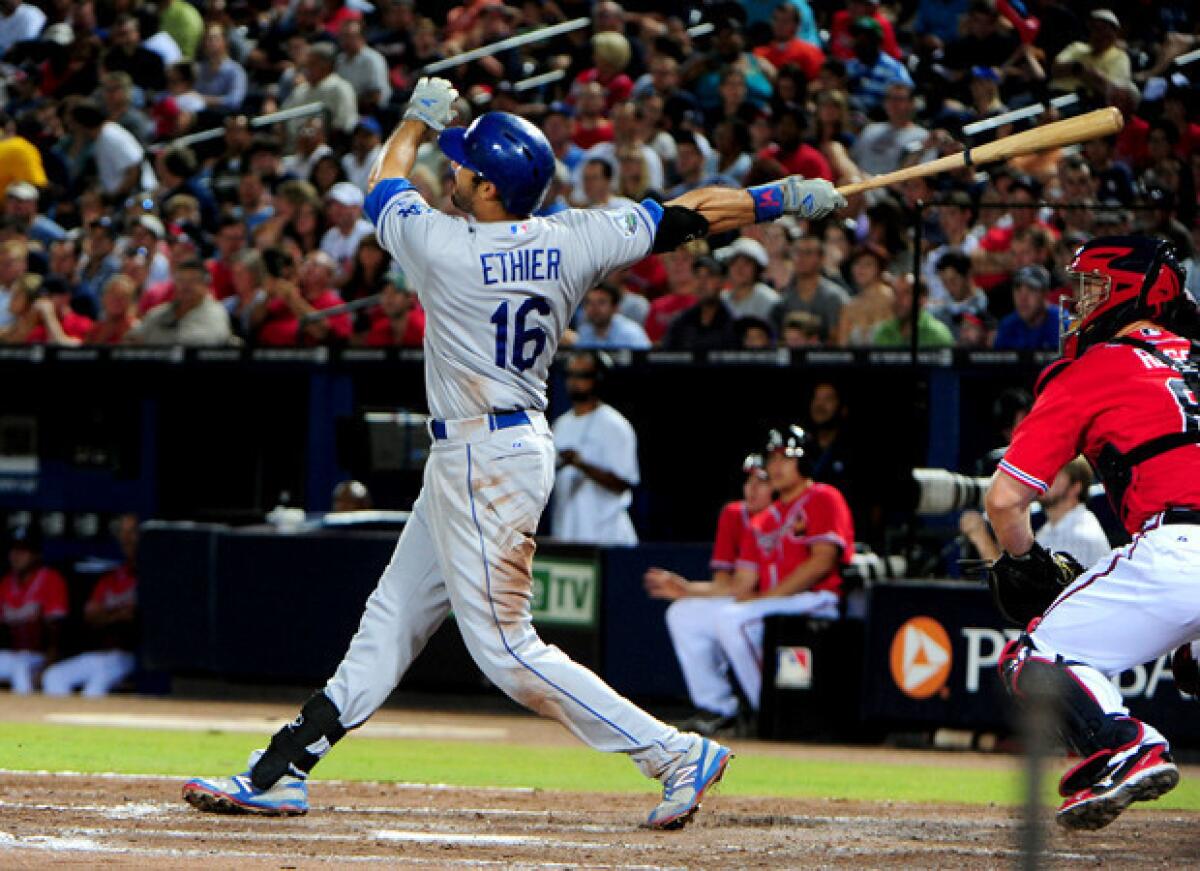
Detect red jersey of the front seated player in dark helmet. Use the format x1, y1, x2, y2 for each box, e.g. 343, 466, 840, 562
738, 483, 854, 594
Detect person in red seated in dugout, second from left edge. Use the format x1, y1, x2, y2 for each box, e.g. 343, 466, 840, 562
42, 515, 138, 698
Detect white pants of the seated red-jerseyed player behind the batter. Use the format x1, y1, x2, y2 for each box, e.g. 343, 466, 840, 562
667, 590, 838, 716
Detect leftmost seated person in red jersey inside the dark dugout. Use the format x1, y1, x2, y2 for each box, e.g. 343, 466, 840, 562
0, 527, 67, 695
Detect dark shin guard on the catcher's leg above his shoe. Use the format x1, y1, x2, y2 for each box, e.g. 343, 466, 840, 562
1000, 635, 1142, 774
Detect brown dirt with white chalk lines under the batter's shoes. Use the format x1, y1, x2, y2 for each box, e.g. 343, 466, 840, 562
0, 773, 1200, 869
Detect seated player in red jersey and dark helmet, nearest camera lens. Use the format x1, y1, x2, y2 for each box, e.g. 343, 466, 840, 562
646, 434, 854, 732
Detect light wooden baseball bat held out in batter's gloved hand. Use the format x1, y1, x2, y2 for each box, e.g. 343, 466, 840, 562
838, 107, 1124, 197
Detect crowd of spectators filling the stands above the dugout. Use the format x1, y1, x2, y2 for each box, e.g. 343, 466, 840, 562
0, 0, 1200, 349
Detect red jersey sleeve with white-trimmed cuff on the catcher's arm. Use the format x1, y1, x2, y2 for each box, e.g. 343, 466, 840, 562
1000, 365, 1094, 493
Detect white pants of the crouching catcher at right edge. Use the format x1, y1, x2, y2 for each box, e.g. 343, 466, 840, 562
1030, 516, 1200, 743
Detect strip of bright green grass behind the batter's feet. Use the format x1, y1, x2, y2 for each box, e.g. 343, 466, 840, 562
7, 722, 1200, 810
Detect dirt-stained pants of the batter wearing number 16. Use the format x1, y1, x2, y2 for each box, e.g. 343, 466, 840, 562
325, 412, 694, 777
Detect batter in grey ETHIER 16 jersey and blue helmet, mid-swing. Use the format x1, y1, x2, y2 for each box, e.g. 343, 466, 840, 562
184, 79, 845, 828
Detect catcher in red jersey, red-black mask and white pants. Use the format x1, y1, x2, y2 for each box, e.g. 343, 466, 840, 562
986, 236, 1200, 829
